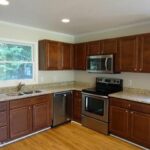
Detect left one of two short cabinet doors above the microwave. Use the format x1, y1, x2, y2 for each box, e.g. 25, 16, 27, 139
87, 41, 101, 55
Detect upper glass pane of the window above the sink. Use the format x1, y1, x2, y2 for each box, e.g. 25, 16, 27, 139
0, 42, 32, 62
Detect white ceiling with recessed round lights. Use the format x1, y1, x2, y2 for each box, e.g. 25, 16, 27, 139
0, 0, 150, 35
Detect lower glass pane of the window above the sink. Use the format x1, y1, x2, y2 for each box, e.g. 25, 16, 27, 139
0, 62, 33, 80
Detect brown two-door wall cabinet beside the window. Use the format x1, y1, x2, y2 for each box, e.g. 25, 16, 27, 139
39, 40, 73, 70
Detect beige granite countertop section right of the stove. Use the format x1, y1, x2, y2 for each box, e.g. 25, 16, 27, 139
109, 89, 150, 104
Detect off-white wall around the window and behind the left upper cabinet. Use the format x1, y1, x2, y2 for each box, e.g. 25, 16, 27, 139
0, 22, 74, 87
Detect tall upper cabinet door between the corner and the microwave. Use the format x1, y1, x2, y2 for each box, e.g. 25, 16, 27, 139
74, 43, 86, 70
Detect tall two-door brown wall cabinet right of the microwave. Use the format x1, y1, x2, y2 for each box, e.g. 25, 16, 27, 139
119, 34, 150, 72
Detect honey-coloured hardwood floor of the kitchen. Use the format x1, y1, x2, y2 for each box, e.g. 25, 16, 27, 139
0, 123, 140, 150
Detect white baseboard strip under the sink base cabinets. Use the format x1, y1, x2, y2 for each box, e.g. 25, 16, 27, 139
0, 127, 51, 147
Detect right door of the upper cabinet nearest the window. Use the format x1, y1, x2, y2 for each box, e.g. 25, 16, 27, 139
62, 43, 73, 70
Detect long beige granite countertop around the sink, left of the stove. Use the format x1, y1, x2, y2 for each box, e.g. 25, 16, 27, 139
0, 84, 91, 102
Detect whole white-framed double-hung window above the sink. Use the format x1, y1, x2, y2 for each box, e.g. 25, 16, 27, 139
0, 41, 35, 81
